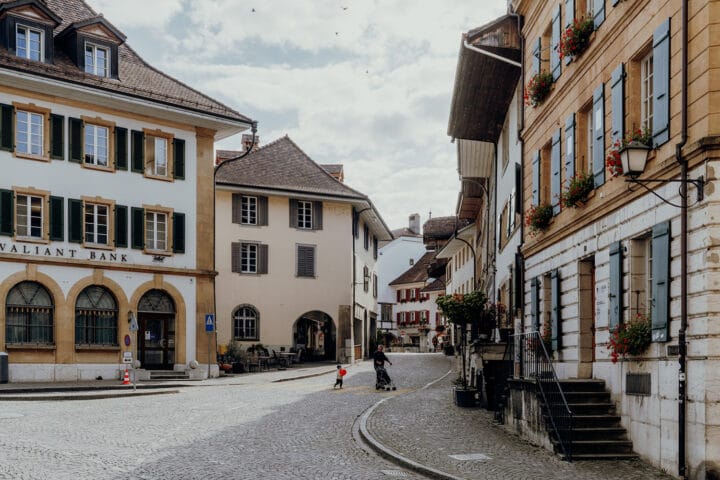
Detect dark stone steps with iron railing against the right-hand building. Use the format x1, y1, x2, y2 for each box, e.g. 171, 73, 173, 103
543, 380, 637, 460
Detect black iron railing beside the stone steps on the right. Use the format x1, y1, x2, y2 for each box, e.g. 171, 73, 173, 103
513, 331, 573, 461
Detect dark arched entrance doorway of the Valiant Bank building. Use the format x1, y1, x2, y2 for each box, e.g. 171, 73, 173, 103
138, 289, 175, 370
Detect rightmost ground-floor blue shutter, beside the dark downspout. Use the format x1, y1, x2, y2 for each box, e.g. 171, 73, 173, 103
651, 221, 670, 342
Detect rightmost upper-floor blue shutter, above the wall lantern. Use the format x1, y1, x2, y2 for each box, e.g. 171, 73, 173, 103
652, 18, 670, 146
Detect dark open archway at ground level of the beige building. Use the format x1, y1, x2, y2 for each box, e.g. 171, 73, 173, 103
293, 310, 337, 362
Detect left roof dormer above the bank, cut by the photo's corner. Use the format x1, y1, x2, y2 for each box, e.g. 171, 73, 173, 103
0, 0, 62, 63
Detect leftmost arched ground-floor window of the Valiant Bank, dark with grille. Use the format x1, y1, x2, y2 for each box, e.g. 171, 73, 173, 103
5, 282, 54, 345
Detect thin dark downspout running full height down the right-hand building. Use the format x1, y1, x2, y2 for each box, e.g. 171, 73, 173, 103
675, 0, 688, 479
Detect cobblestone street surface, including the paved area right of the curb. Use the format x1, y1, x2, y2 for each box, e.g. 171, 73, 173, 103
0, 354, 662, 480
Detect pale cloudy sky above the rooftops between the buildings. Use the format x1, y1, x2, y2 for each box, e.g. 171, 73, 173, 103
86, 0, 506, 229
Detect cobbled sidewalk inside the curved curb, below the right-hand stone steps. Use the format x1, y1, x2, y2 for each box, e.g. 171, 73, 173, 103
366, 375, 672, 480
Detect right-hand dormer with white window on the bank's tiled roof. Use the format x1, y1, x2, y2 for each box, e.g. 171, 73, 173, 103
58, 15, 125, 78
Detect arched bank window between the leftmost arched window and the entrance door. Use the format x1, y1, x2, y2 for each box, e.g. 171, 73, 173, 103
75, 285, 118, 346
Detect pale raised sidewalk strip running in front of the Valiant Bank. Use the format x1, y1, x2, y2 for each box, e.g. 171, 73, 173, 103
0, 364, 336, 402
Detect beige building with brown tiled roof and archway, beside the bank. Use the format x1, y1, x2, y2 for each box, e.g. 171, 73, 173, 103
216, 136, 392, 361
